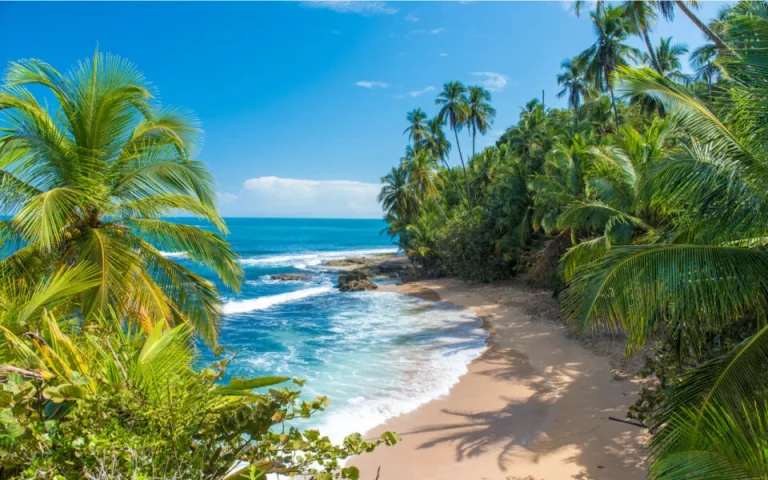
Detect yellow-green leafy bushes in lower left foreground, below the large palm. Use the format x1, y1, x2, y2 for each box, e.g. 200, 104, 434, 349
0, 323, 397, 480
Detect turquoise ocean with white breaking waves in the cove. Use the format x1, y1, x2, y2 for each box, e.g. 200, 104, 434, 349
172, 218, 487, 441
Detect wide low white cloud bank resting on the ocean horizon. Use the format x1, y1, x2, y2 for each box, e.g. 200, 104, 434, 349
219, 177, 382, 218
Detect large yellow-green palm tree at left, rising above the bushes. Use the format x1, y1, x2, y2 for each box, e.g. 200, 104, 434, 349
0, 52, 242, 344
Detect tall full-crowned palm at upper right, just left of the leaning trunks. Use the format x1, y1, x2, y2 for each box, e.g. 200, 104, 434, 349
580, 6, 640, 130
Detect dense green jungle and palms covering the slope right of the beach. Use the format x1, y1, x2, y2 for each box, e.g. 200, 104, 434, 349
381, 1, 768, 479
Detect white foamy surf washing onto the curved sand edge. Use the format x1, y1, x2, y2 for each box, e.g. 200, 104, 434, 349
308, 293, 488, 442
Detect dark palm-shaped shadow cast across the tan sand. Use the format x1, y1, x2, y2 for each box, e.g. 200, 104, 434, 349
392, 342, 636, 479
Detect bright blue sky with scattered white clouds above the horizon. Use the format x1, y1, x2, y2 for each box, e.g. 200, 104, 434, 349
0, 1, 724, 218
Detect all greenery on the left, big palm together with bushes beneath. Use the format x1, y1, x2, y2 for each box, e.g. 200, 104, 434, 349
0, 52, 392, 479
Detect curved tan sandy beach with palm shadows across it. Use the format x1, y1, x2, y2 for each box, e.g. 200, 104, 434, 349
350, 279, 647, 480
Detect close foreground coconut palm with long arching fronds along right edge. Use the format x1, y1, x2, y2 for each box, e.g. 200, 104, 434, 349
563, 18, 768, 472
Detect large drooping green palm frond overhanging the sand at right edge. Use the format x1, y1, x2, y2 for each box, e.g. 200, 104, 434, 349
562, 245, 768, 349
